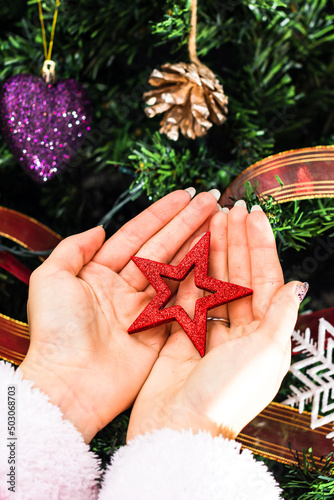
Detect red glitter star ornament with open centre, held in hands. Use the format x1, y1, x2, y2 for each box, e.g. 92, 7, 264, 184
128, 231, 253, 357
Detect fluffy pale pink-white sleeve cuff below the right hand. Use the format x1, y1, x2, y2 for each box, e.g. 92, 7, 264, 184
99, 429, 280, 500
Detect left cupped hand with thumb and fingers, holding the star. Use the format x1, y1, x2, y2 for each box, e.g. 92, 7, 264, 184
20, 191, 217, 442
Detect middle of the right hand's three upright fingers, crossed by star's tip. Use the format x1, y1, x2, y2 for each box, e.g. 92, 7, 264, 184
228, 200, 254, 326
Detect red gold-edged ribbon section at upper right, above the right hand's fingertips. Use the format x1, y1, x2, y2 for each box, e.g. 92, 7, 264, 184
220, 146, 334, 206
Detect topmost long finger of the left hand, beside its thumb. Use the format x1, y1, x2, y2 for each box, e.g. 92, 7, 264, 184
94, 188, 193, 272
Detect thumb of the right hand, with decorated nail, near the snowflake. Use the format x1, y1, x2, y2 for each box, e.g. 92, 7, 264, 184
259, 281, 309, 350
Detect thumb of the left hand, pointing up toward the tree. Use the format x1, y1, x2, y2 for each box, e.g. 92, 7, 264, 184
35, 226, 105, 276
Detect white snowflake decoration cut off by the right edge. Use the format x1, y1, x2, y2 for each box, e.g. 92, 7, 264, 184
282, 318, 334, 438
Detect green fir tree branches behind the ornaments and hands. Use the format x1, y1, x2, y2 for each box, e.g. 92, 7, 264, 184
0, 0, 334, 494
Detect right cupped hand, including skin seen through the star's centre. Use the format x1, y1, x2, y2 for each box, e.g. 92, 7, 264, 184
127, 204, 304, 440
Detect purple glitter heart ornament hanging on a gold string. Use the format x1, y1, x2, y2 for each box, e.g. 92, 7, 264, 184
0, 74, 92, 183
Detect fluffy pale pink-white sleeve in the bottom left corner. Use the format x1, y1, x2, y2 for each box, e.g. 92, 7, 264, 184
0, 361, 100, 500
